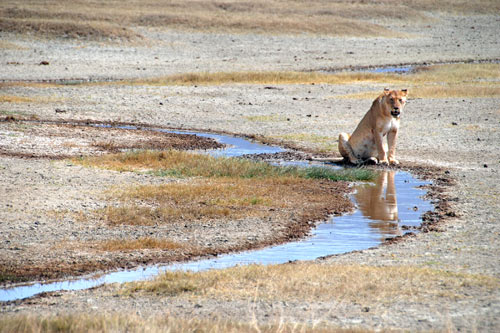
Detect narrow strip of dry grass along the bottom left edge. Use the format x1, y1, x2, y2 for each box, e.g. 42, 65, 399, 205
0, 313, 366, 333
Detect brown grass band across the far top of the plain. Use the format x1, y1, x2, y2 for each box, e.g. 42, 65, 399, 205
5, 0, 500, 40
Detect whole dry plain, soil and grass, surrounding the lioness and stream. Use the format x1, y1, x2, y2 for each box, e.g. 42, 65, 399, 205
0, 0, 500, 332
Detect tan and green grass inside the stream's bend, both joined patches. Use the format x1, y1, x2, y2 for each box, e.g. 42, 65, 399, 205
74, 151, 360, 225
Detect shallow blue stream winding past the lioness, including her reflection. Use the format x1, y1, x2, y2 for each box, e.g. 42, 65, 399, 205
0, 128, 433, 301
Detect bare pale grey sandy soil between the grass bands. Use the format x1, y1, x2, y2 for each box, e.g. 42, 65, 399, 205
0, 11, 500, 332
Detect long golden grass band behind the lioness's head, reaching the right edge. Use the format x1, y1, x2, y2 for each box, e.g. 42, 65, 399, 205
99, 64, 500, 91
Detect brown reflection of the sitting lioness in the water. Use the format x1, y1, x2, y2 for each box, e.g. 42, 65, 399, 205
354, 171, 400, 235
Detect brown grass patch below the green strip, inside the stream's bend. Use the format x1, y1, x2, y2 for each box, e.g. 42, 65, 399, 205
97, 177, 350, 225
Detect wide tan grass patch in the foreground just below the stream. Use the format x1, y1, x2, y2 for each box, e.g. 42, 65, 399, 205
122, 263, 500, 305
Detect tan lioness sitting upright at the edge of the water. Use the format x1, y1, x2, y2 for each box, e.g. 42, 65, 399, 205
339, 89, 408, 164
